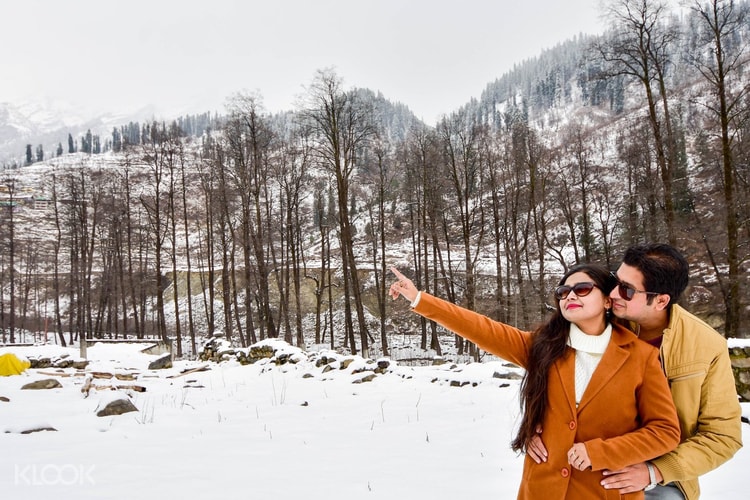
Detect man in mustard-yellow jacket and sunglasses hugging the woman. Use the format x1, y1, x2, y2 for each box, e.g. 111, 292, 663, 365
527, 244, 742, 500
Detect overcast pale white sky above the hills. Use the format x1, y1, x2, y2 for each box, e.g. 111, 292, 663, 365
0, 0, 602, 123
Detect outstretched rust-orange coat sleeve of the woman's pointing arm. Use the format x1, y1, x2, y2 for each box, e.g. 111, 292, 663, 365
414, 292, 531, 368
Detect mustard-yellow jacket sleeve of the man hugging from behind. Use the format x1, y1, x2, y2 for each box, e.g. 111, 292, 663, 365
652, 344, 742, 483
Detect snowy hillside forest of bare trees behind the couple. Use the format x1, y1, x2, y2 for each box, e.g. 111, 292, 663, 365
0, 0, 750, 356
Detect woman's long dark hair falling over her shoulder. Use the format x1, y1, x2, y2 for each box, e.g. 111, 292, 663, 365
511, 264, 616, 452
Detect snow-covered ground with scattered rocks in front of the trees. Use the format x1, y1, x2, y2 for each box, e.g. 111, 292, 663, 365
0, 343, 750, 500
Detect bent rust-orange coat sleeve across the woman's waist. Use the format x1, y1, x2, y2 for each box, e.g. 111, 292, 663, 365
584, 348, 680, 470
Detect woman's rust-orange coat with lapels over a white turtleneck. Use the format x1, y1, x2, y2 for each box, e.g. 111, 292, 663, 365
414, 292, 680, 500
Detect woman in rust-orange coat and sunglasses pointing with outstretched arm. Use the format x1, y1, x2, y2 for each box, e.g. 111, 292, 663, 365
389, 264, 680, 500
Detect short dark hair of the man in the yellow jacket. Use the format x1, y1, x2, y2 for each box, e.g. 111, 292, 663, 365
622, 243, 689, 304
